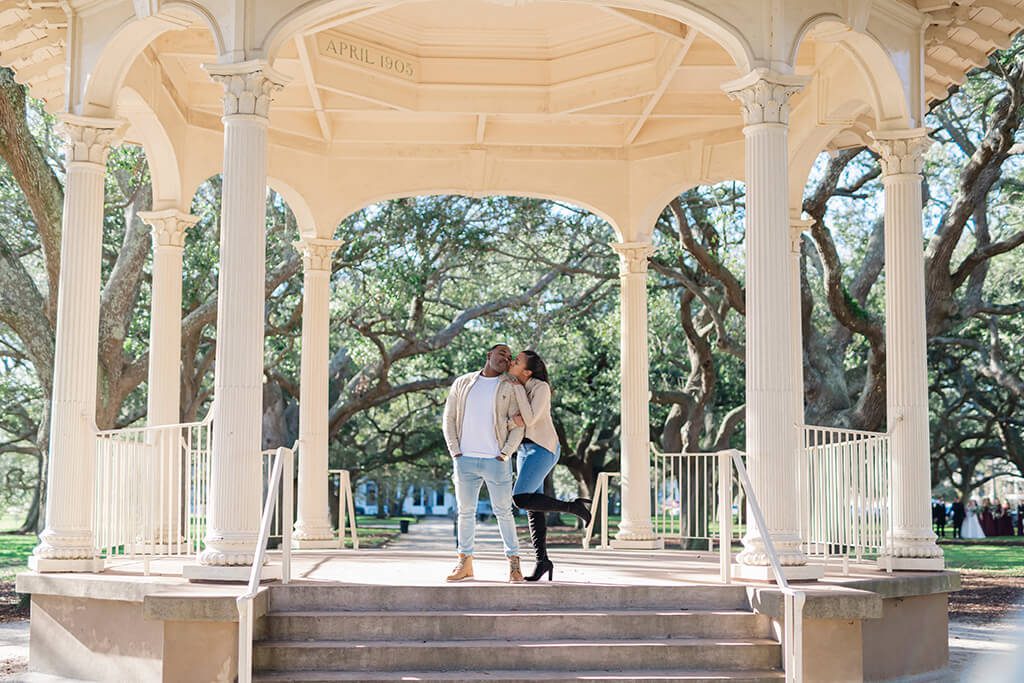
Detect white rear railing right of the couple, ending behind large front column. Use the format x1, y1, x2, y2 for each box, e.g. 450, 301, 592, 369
651, 449, 744, 551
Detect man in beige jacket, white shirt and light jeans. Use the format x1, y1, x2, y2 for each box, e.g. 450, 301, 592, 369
441, 344, 524, 583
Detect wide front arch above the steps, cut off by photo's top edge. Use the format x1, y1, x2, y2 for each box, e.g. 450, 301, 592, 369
255, 0, 755, 71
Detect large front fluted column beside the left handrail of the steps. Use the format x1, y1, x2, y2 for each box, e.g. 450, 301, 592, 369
185, 61, 284, 580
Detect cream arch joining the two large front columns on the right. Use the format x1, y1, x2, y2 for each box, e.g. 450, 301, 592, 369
790, 13, 913, 129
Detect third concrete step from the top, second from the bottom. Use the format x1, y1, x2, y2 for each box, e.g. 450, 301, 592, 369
253, 638, 781, 672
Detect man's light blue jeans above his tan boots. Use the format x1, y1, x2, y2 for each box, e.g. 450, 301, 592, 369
452, 456, 519, 557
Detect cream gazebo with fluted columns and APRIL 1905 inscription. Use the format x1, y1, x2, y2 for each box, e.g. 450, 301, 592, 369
9, 0, 1024, 679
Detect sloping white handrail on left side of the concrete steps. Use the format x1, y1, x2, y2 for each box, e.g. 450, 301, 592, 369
237, 442, 298, 683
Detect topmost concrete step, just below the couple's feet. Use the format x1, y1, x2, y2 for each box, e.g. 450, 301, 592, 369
270, 582, 750, 611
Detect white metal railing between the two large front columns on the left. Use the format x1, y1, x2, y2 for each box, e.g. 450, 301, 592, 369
93, 409, 214, 574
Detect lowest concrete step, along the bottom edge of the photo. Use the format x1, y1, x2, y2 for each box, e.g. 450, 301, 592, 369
253, 668, 785, 683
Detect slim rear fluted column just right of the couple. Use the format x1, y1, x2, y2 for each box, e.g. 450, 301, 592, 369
611, 242, 664, 549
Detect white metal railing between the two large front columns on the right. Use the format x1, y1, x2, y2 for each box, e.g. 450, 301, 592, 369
800, 425, 892, 573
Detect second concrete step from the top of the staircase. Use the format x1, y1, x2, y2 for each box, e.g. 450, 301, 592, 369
266, 609, 771, 640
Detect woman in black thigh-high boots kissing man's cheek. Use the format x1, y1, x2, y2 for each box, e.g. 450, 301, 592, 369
509, 350, 590, 581
